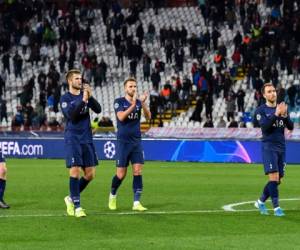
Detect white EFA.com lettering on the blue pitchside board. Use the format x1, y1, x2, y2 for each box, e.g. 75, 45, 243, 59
0, 141, 44, 156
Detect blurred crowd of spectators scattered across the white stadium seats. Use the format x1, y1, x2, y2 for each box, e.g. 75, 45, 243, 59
0, 0, 300, 129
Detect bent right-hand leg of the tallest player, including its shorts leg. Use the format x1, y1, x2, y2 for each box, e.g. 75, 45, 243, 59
79, 144, 98, 193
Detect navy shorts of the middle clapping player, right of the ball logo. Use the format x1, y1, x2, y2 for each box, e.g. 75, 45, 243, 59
116, 141, 144, 168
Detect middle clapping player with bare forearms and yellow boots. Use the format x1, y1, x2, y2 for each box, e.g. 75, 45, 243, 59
108, 78, 151, 211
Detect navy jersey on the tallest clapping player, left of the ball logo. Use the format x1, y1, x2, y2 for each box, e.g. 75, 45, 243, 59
60, 92, 101, 144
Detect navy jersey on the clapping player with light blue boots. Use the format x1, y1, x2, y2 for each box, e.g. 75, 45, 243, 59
255, 104, 294, 151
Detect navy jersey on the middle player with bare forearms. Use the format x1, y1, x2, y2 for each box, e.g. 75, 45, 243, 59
114, 97, 142, 143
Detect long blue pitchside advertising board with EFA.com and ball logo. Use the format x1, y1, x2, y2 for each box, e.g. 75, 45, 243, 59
0, 138, 300, 163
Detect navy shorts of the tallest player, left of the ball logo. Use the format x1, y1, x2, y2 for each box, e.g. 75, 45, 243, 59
66, 143, 98, 168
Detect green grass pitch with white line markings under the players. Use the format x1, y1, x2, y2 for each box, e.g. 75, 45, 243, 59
0, 159, 300, 250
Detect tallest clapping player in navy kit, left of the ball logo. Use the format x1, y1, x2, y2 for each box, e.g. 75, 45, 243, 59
60, 69, 101, 217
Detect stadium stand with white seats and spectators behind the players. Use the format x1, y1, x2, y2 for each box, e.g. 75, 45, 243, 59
0, 0, 300, 133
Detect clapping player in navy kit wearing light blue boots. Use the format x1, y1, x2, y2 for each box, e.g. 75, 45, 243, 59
255, 83, 294, 216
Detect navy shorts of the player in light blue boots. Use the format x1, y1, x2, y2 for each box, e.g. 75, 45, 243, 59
263, 149, 286, 177
